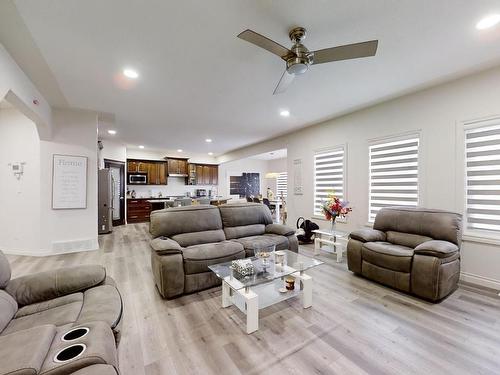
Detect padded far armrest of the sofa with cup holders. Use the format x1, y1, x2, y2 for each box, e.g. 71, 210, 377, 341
5, 265, 106, 306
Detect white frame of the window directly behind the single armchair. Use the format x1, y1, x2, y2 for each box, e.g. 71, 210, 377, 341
367, 130, 423, 226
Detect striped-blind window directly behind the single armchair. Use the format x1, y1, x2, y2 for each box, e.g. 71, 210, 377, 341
368, 135, 420, 222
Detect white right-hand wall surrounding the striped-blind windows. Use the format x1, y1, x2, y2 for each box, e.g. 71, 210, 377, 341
219, 64, 500, 288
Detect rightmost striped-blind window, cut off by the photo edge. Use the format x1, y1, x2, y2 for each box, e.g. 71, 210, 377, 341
465, 119, 500, 234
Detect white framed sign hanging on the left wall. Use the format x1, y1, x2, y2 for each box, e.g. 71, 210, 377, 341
52, 154, 87, 210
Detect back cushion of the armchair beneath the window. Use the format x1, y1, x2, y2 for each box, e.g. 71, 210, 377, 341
373, 207, 462, 247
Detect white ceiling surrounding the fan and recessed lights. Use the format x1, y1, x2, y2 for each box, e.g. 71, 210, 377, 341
10, 0, 500, 155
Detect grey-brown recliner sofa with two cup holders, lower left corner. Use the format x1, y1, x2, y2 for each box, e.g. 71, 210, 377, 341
0, 251, 122, 375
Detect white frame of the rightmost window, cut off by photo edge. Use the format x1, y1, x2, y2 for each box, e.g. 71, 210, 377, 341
455, 115, 500, 245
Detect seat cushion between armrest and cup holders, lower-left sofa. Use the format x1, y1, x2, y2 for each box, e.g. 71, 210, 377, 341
2, 293, 82, 335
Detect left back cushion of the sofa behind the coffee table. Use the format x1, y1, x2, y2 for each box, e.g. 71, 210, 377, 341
149, 206, 222, 238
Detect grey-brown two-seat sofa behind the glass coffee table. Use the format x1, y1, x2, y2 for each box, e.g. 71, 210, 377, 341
150, 203, 298, 298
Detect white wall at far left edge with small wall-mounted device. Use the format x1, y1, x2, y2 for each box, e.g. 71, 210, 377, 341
0, 108, 40, 252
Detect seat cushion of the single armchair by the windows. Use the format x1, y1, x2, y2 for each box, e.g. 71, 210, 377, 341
361, 242, 413, 272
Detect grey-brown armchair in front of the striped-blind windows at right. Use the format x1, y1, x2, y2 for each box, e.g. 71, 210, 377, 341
347, 207, 462, 301
